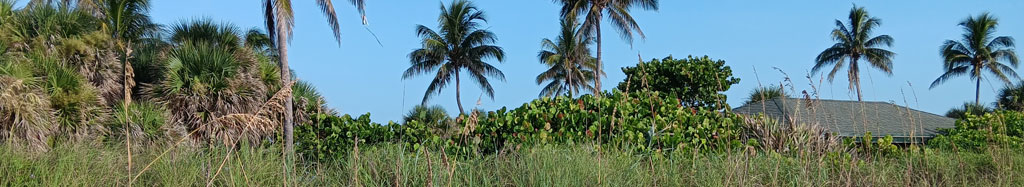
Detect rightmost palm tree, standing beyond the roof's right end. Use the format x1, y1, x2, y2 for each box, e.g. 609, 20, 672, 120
930, 12, 1019, 103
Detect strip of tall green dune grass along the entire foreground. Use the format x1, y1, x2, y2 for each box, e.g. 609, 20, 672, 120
0, 145, 1024, 186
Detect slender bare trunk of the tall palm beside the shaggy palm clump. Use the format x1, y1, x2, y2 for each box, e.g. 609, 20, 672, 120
278, 28, 295, 157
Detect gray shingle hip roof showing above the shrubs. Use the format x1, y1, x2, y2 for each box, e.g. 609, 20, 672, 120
732, 98, 956, 142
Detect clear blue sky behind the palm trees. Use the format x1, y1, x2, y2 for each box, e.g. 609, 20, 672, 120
138, 0, 1024, 123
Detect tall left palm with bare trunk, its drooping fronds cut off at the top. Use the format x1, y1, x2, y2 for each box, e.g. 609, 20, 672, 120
261, 0, 367, 152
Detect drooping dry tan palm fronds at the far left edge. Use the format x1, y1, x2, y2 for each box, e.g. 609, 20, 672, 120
0, 76, 55, 150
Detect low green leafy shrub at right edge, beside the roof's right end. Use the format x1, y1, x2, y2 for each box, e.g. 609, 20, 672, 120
929, 110, 1024, 151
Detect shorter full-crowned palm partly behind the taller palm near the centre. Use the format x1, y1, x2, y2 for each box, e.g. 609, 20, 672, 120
537, 17, 596, 97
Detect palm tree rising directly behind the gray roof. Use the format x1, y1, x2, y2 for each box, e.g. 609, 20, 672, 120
811, 5, 896, 101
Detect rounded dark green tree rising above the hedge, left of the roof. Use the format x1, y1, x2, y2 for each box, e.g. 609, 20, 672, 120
618, 56, 739, 109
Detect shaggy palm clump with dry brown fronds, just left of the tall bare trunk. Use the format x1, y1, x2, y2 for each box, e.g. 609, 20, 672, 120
141, 45, 273, 145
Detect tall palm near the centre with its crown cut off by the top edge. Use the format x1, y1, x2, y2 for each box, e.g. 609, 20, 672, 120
553, 0, 658, 95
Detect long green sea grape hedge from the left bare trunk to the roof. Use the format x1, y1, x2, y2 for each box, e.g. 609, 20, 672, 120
296, 91, 743, 159
